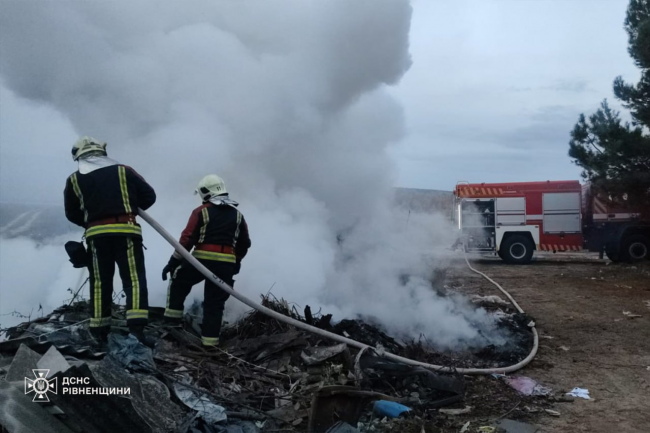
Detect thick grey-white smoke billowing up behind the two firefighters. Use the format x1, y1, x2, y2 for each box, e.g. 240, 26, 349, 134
0, 0, 498, 346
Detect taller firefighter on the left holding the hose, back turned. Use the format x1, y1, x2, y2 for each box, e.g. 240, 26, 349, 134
64, 137, 156, 346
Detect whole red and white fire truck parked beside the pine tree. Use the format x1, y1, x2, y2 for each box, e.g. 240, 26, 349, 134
454, 180, 650, 264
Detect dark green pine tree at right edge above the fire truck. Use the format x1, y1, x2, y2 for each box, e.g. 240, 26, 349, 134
569, 0, 650, 208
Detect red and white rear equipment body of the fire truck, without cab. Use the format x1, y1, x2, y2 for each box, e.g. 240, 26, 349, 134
454, 181, 583, 264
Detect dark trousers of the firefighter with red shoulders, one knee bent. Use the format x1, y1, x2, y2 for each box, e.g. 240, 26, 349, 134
165, 260, 236, 346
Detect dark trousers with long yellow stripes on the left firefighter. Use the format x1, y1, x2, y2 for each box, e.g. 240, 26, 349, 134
87, 236, 149, 332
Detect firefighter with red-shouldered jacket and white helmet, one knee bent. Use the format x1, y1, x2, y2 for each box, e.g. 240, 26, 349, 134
162, 174, 251, 347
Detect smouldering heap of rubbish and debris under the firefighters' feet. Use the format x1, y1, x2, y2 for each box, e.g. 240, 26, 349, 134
0, 295, 548, 432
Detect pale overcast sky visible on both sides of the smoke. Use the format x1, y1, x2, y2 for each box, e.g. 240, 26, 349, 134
0, 0, 638, 203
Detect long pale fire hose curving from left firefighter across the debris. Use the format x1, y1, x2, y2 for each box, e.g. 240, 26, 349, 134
138, 209, 539, 374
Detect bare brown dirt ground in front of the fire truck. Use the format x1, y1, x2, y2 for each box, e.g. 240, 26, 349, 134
448, 253, 650, 433
